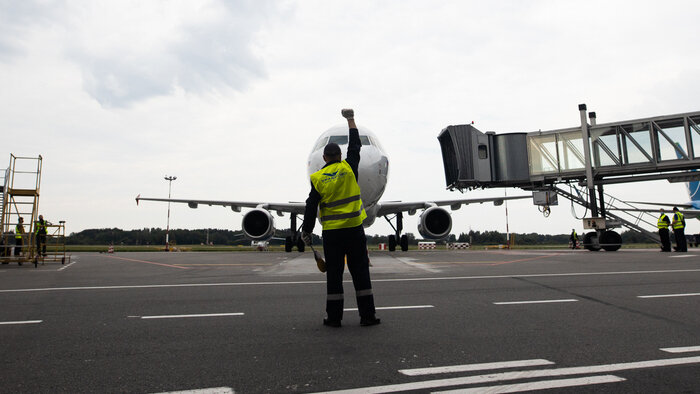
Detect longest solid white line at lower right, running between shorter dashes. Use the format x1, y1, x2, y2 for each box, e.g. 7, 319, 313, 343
318, 357, 700, 394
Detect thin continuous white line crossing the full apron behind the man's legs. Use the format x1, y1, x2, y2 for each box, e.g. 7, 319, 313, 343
0, 267, 700, 293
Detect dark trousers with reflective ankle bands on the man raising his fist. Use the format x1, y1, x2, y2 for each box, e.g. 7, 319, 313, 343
322, 226, 375, 321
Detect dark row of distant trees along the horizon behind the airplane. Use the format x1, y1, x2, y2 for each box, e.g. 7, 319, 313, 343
66, 228, 650, 245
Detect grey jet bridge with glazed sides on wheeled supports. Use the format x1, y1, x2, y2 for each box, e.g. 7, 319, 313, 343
438, 104, 700, 250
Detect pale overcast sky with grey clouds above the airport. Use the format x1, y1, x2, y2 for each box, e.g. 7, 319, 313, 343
0, 0, 700, 239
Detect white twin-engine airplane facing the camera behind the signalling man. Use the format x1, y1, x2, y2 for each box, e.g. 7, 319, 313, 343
136, 126, 532, 252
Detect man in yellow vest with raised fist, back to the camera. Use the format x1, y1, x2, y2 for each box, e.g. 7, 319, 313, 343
302, 109, 380, 327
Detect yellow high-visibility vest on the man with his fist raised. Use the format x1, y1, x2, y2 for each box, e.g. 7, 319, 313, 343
311, 160, 367, 230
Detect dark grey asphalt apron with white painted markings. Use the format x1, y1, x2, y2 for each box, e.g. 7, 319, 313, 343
0, 249, 700, 393
